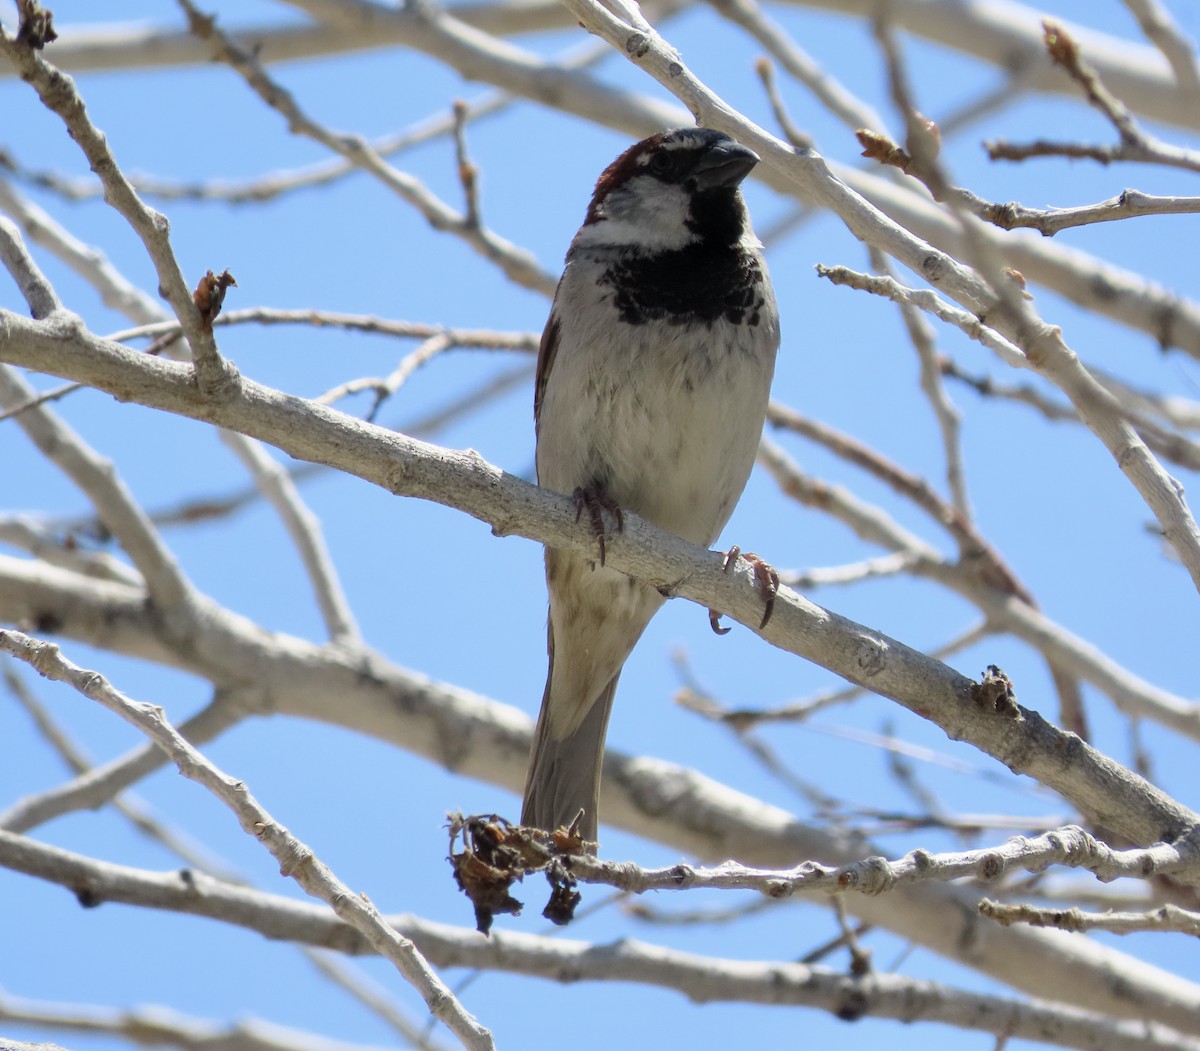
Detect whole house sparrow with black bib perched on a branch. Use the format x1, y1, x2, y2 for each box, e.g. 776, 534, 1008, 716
521, 127, 779, 841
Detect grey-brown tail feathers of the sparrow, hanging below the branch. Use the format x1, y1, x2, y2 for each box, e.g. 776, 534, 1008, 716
521, 654, 620, 842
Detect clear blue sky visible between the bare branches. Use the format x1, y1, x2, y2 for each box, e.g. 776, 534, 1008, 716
0, 0, 1200, 1051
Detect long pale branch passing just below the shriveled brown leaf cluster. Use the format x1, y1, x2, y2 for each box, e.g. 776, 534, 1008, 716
0, 833, 1200, 1051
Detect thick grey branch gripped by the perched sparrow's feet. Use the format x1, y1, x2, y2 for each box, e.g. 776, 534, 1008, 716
0, 312, 1200, 841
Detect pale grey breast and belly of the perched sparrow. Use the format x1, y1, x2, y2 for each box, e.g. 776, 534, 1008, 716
538, 253, 779, 545
